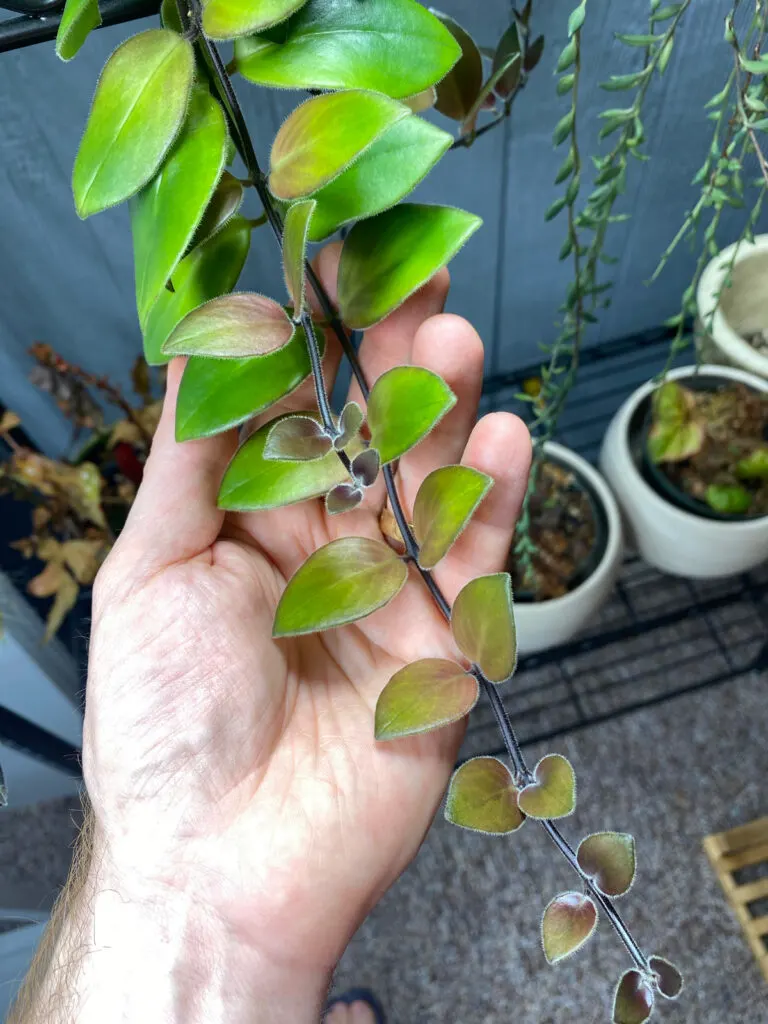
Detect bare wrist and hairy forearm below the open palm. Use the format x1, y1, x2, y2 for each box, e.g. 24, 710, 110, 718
8, 802, 328, 1024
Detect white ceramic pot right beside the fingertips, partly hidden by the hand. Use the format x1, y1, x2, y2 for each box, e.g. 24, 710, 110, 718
515, 442, 624, 654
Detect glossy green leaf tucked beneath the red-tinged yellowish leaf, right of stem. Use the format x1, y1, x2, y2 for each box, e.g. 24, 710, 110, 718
309, 117, 453, 242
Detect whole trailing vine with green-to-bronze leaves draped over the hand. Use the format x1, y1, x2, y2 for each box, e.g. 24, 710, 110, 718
57, 0, 682, 1024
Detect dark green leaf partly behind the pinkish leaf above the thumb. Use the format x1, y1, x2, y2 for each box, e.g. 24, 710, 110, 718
144, 211, 251, 366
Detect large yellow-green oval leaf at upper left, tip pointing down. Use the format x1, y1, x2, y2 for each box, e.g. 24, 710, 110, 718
72, 29, 195, 218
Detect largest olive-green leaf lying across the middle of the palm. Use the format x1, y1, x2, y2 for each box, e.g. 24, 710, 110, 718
272, 537, 408, 637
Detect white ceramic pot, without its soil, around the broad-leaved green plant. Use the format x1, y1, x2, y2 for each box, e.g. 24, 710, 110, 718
600, 365, 768, 579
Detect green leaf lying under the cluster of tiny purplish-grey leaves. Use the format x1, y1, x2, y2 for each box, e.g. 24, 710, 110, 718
218, 414, 349, 512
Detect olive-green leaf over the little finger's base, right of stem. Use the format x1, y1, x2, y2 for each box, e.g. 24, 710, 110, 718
414, 466, 494, 569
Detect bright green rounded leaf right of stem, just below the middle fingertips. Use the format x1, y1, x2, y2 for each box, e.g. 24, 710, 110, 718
368, 367, 456, 465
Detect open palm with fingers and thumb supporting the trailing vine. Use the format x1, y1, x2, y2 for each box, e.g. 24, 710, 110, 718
83, 247, 529, 983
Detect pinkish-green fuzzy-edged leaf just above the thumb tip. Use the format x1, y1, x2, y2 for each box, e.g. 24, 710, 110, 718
163, 292, 296, 358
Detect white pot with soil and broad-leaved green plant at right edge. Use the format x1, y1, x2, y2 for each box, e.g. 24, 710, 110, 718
600, 365, 768, 578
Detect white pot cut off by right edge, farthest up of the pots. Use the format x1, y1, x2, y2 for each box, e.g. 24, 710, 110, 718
696, 234, 768, 377
